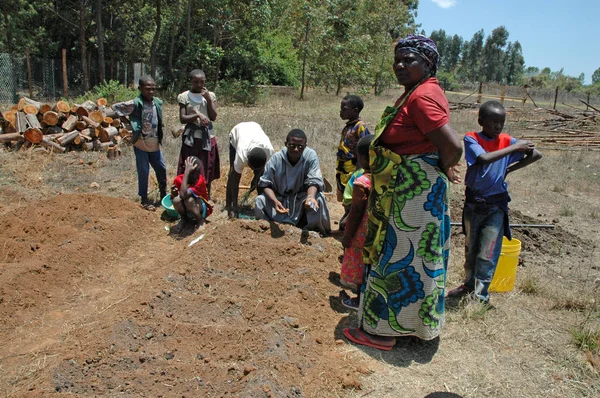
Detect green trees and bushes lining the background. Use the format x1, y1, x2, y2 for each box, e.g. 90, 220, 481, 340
0, 0, 600, 98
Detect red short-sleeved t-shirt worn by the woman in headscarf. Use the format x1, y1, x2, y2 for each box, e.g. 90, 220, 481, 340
379, 77, 450, 155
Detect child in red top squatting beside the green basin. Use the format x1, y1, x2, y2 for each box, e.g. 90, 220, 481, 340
171, 156, 212, 233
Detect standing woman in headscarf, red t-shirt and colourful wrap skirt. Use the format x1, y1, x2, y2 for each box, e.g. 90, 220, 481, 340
344, 35, 462, 350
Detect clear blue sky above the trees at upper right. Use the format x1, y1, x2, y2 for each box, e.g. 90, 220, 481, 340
417, 0, 600, 84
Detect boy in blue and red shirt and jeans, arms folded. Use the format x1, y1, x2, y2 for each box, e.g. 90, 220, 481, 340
447, 101, 542, 303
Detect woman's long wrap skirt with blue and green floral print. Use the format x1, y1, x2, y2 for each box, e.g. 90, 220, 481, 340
359, 154, 450, 340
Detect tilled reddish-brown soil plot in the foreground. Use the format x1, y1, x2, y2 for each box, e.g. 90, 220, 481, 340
0, 195, 364, 397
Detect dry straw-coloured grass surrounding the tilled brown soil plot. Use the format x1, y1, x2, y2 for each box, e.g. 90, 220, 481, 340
0, 91, 600, 398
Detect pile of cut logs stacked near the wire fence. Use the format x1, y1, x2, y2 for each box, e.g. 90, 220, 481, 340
0, 97, 131, 157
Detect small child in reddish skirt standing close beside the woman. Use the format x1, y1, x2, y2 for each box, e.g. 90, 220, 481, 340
340, 135, 373, 309
